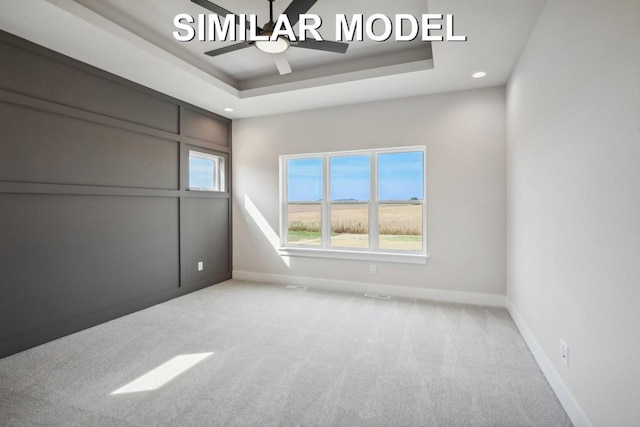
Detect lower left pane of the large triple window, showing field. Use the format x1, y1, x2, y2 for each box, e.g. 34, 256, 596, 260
287, 205, 322, 246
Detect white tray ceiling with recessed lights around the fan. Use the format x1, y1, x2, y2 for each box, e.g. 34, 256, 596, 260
0, 0, 546, 119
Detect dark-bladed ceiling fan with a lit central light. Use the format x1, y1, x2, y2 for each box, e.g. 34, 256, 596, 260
191, 0, 349, 75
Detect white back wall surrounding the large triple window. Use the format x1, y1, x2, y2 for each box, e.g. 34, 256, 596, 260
233, 88, 506, 295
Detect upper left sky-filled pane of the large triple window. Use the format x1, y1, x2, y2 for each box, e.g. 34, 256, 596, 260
287, 158, 322, 202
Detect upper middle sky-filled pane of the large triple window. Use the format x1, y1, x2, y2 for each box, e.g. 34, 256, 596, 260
330, 155, 371, 202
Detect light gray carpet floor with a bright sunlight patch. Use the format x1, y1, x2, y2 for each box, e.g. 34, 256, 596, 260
0, 280, 571, 426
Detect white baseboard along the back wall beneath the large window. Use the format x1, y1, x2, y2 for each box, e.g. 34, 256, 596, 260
233, 270, 505, 307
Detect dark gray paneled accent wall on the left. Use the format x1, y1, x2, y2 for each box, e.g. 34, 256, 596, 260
0, 32, 231, 357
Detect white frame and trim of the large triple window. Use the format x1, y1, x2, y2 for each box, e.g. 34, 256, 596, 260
279, 146, 428, 264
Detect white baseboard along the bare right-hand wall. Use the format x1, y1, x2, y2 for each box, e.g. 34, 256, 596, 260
505, 298, 593, 427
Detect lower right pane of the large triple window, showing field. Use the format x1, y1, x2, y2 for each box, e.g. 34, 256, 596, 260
378, 204, 422, 251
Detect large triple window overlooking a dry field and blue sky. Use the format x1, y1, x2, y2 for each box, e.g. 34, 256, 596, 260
280, 147, 426, 262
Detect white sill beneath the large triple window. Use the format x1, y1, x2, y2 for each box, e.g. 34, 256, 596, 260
279, 247, 428, 264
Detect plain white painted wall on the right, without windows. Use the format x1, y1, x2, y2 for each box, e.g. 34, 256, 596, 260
507, 0, 640, 427
